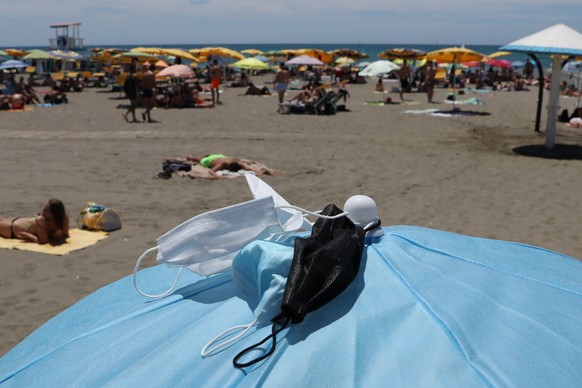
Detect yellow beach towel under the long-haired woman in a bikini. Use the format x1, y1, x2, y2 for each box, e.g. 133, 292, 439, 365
0, 229, 109, 255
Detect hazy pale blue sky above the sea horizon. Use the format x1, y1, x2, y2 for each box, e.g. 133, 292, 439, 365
0, 0, 582, 47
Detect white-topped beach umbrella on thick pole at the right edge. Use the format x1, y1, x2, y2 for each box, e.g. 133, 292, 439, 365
501, 24, 582, 149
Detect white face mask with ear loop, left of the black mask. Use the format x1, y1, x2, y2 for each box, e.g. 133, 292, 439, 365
133, 173, 311, 298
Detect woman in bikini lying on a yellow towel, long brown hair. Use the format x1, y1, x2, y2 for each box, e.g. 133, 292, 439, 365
0, 199, 69, 245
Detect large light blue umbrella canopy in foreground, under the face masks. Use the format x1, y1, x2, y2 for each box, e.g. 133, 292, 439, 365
0, 184, 582, 387
